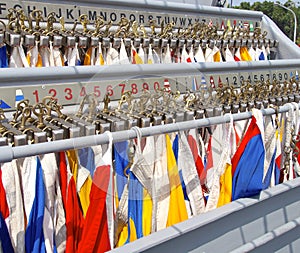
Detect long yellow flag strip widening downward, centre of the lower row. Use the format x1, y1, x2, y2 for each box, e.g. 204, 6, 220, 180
166, 135, 188, 227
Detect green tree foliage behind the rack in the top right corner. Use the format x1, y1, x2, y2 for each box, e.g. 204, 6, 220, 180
234, 0, 300, 45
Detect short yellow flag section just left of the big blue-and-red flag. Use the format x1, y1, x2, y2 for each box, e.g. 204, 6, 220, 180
217, 163, 232, 207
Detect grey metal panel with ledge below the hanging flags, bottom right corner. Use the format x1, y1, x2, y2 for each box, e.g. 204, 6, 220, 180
110, 178, 300, 253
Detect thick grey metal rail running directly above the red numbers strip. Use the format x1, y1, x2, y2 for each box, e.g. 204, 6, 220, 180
0, 59, 300, 87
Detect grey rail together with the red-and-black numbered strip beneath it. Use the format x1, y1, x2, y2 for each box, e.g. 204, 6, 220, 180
0, 59, 300, 111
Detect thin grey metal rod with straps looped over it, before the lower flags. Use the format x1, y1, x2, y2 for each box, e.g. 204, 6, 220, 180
0, 105, 298, 162
